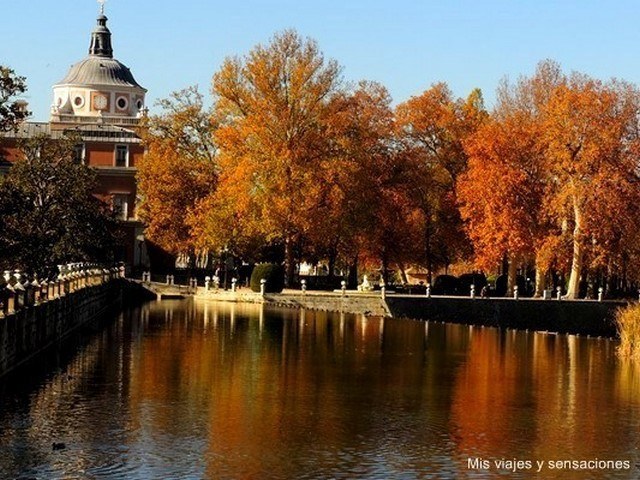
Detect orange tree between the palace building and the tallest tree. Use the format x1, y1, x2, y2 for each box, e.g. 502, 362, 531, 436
138, 87, 218, 266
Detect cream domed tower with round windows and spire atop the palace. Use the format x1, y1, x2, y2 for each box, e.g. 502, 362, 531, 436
51, 5, 147, 128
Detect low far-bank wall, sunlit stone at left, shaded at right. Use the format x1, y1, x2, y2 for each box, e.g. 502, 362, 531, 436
196, 288, 627, 338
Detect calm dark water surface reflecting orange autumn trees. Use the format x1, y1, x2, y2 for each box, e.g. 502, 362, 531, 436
0, 301, 640, 479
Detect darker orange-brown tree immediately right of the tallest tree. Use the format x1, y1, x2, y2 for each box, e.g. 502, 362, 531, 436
312, 82, 420, 287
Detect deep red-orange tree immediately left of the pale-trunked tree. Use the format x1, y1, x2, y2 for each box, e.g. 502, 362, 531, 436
457, 111, 547, 294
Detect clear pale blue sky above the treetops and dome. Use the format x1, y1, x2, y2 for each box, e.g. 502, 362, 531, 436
0, 0, 640, 121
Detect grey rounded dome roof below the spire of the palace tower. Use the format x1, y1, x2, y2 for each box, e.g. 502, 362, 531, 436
57, 55, 146, 91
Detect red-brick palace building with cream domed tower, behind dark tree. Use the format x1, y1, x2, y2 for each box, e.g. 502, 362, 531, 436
0, 5, 148, 267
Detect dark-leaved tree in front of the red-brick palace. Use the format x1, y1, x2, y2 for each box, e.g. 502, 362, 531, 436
0, 136, 116, 274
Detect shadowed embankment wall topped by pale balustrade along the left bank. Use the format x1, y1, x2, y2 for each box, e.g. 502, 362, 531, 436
0, 269, 128, 377
